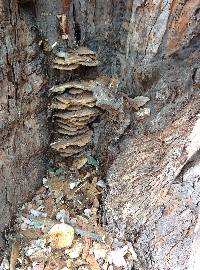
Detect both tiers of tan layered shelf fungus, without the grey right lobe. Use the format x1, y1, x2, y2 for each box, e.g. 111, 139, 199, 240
50, 47, 101, 158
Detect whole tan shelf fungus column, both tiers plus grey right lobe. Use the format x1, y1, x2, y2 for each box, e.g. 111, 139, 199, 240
49, 47, 122, 161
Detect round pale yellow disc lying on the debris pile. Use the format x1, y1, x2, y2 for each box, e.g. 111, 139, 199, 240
48, 223, 74, 249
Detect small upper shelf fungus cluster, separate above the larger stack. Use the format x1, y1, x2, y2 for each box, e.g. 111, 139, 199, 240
53, 47, 98, 70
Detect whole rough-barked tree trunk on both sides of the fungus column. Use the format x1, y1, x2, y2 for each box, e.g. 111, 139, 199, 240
0, 0, 200, 270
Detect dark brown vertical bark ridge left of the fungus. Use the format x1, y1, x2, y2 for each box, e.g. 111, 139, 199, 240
0, 1, 49, 248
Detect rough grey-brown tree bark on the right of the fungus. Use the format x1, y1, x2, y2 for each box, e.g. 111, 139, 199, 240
63, 0, 200, 269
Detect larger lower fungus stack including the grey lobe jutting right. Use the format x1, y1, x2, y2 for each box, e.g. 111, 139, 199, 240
50, 76, 123, 157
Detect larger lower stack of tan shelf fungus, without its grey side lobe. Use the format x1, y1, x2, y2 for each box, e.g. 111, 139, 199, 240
50, 78, 100, 157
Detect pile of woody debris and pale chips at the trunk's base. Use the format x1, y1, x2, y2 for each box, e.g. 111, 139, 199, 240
0, 160, 137, 270
